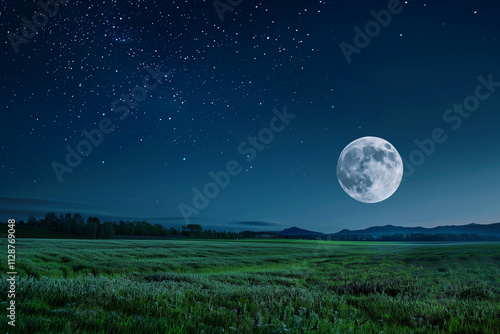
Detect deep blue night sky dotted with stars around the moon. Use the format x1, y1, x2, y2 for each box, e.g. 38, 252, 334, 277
0, 0, 500, 233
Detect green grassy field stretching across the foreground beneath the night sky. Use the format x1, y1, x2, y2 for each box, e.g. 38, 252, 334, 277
0, 239, 500, 334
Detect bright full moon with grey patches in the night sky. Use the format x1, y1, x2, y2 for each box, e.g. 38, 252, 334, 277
337, 137, 403, 203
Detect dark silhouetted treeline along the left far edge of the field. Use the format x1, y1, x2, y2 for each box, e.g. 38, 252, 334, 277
19, 212, 243, 239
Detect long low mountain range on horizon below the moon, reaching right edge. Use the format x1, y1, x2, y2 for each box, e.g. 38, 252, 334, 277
330, 223, 500, 237
